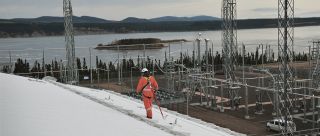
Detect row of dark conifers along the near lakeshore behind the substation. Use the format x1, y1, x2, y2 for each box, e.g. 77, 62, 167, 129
1, 49, 308, 81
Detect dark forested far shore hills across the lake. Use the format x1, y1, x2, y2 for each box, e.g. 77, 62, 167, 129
0, 17, 320, 38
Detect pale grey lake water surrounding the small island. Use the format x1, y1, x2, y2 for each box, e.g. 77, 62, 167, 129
0, 26, 320, 66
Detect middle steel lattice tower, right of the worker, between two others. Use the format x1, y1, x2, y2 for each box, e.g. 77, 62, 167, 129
221, 0, 239, 108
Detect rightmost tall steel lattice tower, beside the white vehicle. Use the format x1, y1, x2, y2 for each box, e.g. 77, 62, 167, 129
277, 0, 294, 135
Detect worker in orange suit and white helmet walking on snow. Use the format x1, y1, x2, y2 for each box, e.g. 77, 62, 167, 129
136, 68, 158, 119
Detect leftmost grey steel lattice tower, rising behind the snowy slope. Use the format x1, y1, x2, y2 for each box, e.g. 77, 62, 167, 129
63, 0, 78, 84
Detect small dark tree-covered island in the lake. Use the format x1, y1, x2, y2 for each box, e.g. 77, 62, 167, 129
95, 38, 187, 50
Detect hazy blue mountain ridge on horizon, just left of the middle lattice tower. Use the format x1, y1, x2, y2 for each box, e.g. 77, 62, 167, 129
149, 16, 220, 22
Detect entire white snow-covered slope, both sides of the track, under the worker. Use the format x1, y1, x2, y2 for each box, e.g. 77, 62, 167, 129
0, 73, 242, 136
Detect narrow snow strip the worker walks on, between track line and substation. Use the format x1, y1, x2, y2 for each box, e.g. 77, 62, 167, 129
48, 79, 243, 136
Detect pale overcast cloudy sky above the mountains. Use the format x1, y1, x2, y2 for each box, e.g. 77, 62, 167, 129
0, 0, 320, 20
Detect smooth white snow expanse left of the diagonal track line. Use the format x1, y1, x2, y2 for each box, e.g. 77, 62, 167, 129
0, 73, 172, 136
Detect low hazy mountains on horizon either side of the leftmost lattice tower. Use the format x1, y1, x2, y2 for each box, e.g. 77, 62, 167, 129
11, 16, 113, 23
